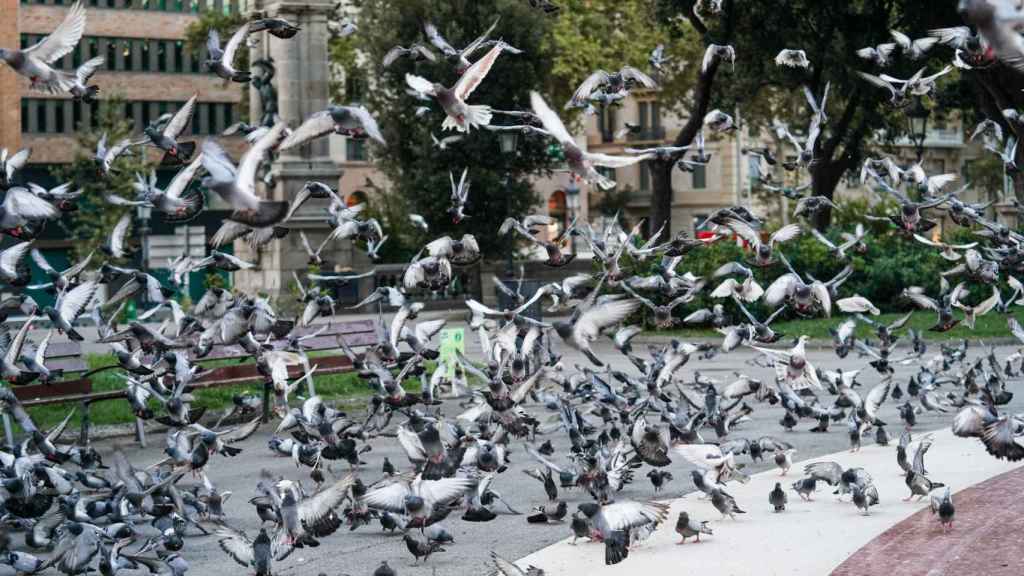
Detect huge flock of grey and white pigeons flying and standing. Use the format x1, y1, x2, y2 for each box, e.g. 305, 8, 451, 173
0, 2, 1024, 576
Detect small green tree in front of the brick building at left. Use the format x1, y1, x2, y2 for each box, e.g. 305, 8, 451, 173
52, 95, 151, 264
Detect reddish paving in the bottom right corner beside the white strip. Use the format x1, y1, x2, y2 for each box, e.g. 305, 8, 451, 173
831, 468, 1024, 576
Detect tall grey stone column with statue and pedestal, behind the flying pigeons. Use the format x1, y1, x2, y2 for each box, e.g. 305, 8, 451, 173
234, 0, 351, 296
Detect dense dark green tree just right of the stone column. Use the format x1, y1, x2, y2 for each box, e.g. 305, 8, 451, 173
348, 0, 555, 253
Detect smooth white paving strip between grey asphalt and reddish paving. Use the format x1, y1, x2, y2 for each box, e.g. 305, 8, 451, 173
517, 429, 1024, 576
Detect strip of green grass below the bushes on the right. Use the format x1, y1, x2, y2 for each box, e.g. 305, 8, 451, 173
662, 311, 1024, 340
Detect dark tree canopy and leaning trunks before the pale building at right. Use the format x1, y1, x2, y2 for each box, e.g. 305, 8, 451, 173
651, 0, 958, 231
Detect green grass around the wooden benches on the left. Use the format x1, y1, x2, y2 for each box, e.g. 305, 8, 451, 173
15, 354, 420, 434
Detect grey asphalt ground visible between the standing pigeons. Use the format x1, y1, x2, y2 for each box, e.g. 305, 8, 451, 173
68, 332, 1024, 576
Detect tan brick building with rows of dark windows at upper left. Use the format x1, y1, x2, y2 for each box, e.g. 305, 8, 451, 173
0, 0, 245, 301
